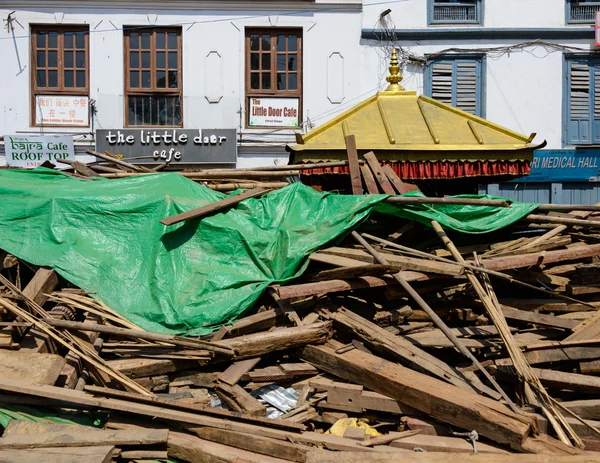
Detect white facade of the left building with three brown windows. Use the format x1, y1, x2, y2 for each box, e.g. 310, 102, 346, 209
0, 0, 362, 167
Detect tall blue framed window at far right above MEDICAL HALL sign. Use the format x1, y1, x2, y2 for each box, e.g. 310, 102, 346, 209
563, 58, 600, 145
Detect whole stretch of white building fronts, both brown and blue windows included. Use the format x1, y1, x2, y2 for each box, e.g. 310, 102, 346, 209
0, 0, 600, 181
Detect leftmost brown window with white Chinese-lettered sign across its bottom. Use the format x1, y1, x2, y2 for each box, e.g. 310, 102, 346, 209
31, 26, 89, 126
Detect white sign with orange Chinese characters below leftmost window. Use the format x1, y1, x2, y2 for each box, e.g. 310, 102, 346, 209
35, 95, 90, 127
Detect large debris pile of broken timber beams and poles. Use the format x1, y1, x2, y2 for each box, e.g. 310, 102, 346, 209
0, 150, 600, 463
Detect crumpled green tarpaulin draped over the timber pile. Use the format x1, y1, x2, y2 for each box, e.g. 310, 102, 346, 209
0, 168, 535, 335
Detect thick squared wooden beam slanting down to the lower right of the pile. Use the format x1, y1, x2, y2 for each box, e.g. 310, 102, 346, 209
300, 346, 532, 450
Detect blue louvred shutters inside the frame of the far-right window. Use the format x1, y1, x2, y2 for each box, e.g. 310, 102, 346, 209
567, 61, 594, 145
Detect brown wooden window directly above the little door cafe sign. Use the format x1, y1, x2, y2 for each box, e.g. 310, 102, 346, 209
125, 27, 182, 127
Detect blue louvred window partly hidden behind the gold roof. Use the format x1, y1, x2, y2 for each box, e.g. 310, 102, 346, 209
425, 57, 485, 117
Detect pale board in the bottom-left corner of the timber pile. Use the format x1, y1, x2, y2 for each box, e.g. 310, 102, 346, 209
0, 445, 115, 463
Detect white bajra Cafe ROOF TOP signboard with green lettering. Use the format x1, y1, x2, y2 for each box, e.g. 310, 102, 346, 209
4, 135, 75, 168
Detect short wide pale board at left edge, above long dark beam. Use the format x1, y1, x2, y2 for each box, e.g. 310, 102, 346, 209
0, 350, 65, 385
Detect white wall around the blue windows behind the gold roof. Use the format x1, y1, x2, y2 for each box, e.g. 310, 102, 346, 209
362, 0, 595, 149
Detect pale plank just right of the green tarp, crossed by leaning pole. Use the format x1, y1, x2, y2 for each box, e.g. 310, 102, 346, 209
319, 247, 463, 276
